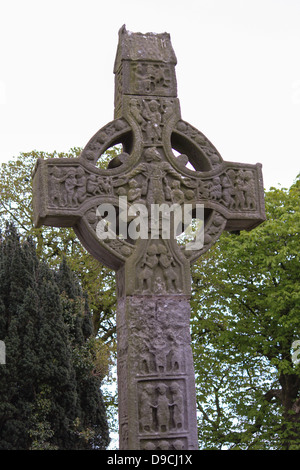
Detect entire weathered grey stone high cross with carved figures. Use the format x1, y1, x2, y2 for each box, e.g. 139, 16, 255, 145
33, 26, 265, 450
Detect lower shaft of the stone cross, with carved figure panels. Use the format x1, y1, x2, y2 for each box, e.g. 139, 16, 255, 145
117, 294, 198, 450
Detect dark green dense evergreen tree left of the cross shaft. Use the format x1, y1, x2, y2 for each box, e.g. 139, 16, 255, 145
0, 225, 109, 450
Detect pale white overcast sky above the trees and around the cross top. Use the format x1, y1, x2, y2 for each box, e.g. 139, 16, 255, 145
0, 0, 300, 189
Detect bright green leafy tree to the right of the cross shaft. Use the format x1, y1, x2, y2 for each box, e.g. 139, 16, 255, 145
192, 177, 300, 449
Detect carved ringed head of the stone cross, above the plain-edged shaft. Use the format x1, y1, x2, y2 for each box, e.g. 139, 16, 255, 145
33, 26, 265, 294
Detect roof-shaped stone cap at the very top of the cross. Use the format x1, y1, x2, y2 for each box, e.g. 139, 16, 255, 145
114, 25, 177, 73
